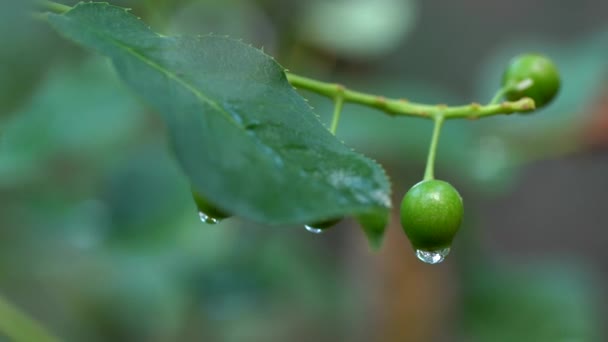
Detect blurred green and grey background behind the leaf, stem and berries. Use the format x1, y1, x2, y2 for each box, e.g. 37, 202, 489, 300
0, 0, 608, 342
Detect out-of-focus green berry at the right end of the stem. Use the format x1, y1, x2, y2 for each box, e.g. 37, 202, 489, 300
502, 54, 560, 108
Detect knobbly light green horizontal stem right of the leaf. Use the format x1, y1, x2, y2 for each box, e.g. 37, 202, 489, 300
287, 73, 535, 119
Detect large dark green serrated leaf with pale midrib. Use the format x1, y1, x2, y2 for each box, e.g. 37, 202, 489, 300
48, 3, 390, 236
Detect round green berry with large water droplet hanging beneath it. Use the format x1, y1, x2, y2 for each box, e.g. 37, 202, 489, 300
401, 180, 464, 251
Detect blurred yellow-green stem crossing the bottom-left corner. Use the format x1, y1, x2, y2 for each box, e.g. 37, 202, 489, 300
0, 297, 59, 342
